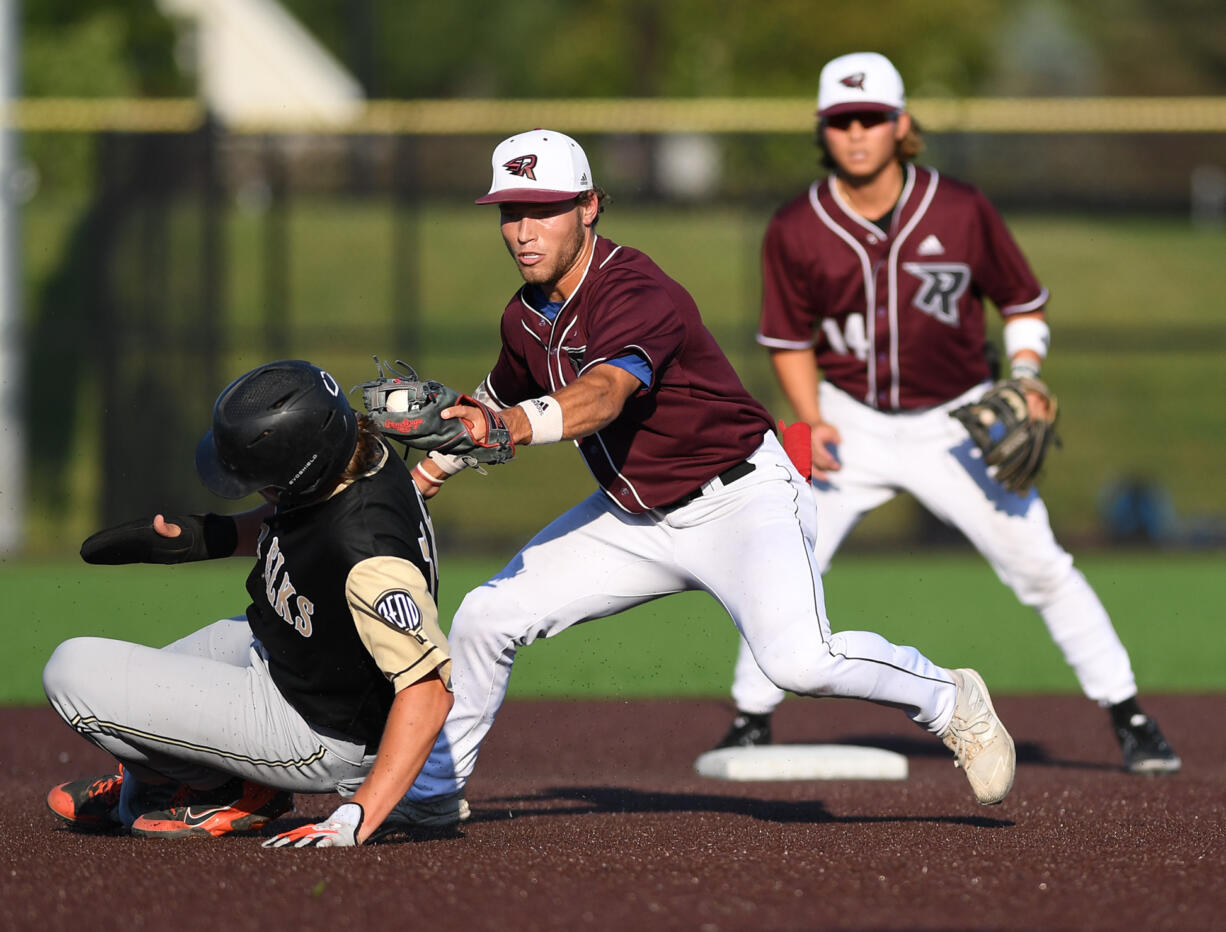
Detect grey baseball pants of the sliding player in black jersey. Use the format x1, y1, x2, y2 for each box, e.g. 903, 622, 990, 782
43, 618, 374, 814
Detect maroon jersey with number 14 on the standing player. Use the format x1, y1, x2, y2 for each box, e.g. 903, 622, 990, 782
758, 164, 1047, 411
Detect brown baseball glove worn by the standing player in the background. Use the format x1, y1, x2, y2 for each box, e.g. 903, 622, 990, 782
949, 379, 1059, 494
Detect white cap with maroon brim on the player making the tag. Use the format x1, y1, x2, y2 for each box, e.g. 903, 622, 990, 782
477, 130, 592, 204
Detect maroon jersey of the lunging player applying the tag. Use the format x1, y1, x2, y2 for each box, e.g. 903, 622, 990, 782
475, 237, 772, 514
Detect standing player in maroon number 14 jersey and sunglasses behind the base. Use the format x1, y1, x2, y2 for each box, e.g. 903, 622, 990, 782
717, 53, 1179, 774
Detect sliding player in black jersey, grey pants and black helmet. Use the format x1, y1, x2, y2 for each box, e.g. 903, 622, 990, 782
43, 361, 452, 847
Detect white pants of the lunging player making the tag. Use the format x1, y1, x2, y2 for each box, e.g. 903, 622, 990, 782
408, 433, 955, 800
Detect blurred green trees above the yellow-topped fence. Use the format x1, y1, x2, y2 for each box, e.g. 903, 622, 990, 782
22, 0, 1226, 98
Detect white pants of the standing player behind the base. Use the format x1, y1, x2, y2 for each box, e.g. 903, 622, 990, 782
732, 383, 1137, 712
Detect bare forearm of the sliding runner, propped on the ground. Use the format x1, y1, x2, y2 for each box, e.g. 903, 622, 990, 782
353, 674, 454, 844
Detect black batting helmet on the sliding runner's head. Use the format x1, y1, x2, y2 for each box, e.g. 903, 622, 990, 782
196, 359, 358, 503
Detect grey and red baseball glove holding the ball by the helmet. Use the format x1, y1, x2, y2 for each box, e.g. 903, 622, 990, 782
354, 357, 515, 464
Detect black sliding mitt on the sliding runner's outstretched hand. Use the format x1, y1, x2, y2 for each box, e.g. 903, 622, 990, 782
81, 513, 238, 565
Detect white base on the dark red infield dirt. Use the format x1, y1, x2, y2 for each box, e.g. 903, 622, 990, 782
694, 744, 907, 780
